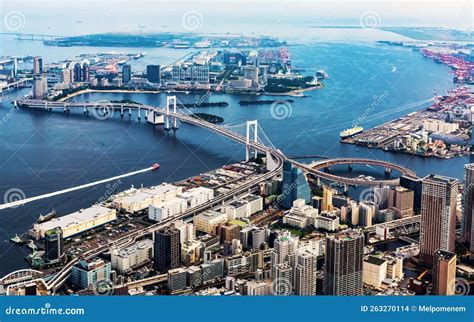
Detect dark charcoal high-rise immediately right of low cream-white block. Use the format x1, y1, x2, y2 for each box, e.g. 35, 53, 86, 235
154, 226, 181, 271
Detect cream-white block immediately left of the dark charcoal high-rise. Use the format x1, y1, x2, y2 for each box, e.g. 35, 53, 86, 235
111, 239, 153, 274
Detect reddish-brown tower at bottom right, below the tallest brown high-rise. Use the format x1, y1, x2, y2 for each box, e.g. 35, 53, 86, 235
433, 250, 456, 295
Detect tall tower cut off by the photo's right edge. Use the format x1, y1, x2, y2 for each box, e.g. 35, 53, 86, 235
462, 163, 474, 259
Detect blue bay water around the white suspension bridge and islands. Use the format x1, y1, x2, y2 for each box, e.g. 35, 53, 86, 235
0, 31, 473, 275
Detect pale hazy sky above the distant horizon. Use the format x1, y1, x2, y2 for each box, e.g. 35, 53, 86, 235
0, 0, 474, 34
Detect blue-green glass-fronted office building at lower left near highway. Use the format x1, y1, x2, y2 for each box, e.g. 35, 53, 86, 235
71, 257, 111, 289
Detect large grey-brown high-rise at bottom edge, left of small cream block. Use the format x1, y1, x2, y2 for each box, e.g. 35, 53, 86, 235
324, 230, 364, 295
